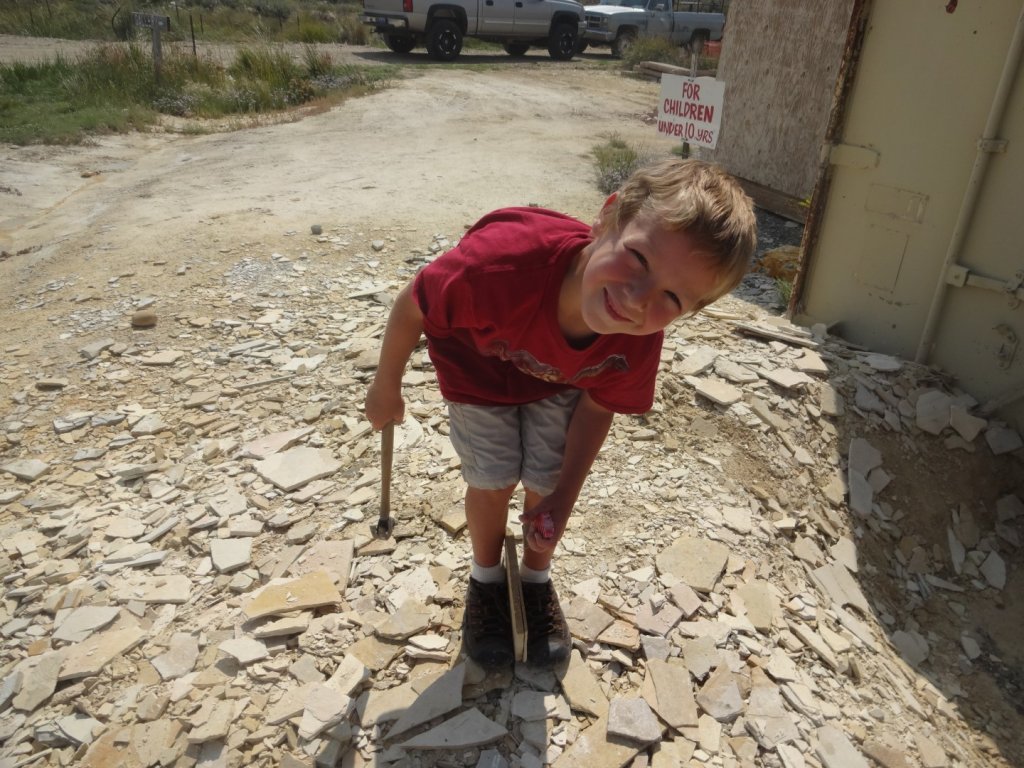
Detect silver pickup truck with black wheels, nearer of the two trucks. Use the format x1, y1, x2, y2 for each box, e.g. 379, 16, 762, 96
360, 0, 584, 61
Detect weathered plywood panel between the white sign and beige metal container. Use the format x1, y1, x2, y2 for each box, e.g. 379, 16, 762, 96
710, 0, 853, 199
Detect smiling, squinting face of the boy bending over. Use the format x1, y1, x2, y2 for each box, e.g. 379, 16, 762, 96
577, 214, 720, 336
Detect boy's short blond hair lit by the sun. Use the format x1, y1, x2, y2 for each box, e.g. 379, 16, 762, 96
599, 158, 757, 311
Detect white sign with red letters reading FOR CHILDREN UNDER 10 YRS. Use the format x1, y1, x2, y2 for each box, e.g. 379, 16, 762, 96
657, 75, 725, 150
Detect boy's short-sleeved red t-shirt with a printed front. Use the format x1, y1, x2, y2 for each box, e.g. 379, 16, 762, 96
413, 208, 663, 414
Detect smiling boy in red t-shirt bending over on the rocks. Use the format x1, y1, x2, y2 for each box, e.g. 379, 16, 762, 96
366, 159, 756, 667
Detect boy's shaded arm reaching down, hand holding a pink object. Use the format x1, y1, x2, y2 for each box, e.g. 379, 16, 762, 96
522, 392, 614, 552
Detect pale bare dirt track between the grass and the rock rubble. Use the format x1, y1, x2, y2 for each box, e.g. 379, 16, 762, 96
0, 43, 671, 352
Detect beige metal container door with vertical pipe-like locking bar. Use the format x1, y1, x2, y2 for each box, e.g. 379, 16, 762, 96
794, 0, 1024, 427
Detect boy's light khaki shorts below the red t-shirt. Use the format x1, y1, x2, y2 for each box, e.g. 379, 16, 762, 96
447, 389, 580, 496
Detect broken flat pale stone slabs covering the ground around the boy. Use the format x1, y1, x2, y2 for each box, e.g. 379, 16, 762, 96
0, 227, 1024, 768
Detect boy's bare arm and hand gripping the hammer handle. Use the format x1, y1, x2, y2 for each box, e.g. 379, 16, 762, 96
366, 283, 423, 429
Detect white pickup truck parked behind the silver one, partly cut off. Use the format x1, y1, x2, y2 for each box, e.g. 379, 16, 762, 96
583, 0, 725, 57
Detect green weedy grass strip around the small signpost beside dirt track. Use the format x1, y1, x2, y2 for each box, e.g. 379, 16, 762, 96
0, 43, 394, 144
